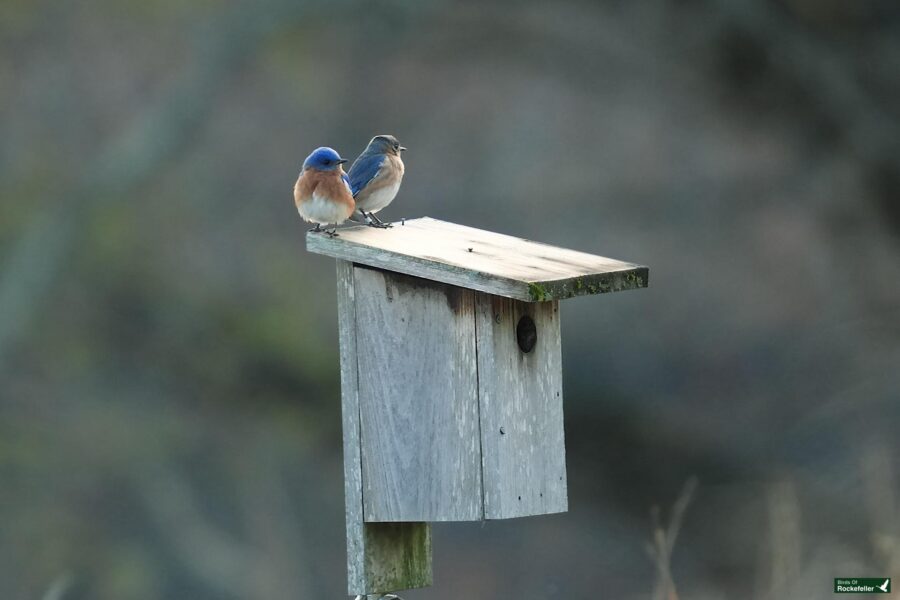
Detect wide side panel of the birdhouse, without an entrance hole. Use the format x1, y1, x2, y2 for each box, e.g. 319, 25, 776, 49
354, 266, 483, 522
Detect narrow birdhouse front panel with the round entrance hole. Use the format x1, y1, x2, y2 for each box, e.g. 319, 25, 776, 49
475, 293, 568, 519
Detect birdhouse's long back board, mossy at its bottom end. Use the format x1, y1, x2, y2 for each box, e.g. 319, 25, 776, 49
337, 260, 431, 595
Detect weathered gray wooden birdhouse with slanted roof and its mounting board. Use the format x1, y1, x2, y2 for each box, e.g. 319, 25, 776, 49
306, 218, 648, 595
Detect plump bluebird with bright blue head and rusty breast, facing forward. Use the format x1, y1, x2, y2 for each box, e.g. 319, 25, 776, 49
294, 147, 356, 237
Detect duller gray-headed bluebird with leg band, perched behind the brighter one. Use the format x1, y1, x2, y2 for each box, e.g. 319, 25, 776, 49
348, 135, 406, 227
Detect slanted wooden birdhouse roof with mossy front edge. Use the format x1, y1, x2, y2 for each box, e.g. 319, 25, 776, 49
306, 217, 648, 302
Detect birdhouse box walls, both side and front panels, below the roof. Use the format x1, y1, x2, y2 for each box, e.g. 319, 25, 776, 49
353, 266, 567, 522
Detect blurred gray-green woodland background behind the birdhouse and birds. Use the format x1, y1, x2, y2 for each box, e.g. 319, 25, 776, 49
0, 0, 900, 600
